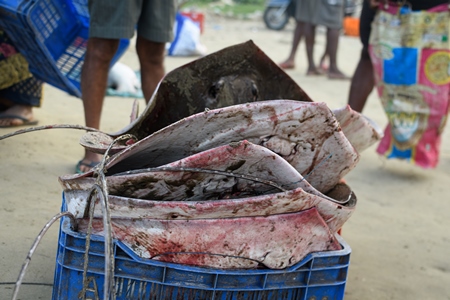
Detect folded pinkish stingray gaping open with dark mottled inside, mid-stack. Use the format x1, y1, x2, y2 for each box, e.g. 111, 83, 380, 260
60, 141, 356, 232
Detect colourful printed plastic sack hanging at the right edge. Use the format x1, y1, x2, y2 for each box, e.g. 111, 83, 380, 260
369, 4, 450, 168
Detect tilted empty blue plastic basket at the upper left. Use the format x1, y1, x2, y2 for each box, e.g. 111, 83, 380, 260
0, 0, 129, 97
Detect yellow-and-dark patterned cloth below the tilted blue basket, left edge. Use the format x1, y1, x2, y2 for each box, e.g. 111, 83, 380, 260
0, 29, 42, 107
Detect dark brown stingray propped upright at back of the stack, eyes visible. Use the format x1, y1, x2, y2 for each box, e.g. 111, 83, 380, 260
107, 41, 312, 139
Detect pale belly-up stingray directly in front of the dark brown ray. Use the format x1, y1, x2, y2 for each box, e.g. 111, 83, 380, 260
74, 100, 359, 193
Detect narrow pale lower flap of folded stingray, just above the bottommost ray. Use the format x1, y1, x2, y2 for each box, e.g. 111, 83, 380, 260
65, 183, 357, 233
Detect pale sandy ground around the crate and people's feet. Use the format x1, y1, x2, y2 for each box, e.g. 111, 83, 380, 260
0, 12, 450, 300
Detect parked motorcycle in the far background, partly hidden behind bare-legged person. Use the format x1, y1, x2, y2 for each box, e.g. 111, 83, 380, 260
263, 0, 357, 30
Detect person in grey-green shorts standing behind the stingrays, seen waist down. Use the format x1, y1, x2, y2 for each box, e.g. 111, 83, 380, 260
76, 0, 176, 173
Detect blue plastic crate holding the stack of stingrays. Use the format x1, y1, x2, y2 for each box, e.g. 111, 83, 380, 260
53, 214, 351, 300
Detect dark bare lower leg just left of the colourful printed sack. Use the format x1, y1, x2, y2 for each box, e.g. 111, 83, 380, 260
348, 48, 375, 112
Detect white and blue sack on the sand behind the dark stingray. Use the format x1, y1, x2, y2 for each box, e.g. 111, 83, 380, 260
166, 13, 206, 56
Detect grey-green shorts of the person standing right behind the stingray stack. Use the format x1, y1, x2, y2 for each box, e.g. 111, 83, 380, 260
88, 0, 176, 43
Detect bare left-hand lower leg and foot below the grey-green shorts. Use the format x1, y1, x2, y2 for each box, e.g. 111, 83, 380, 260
80, 38, 119, 172
